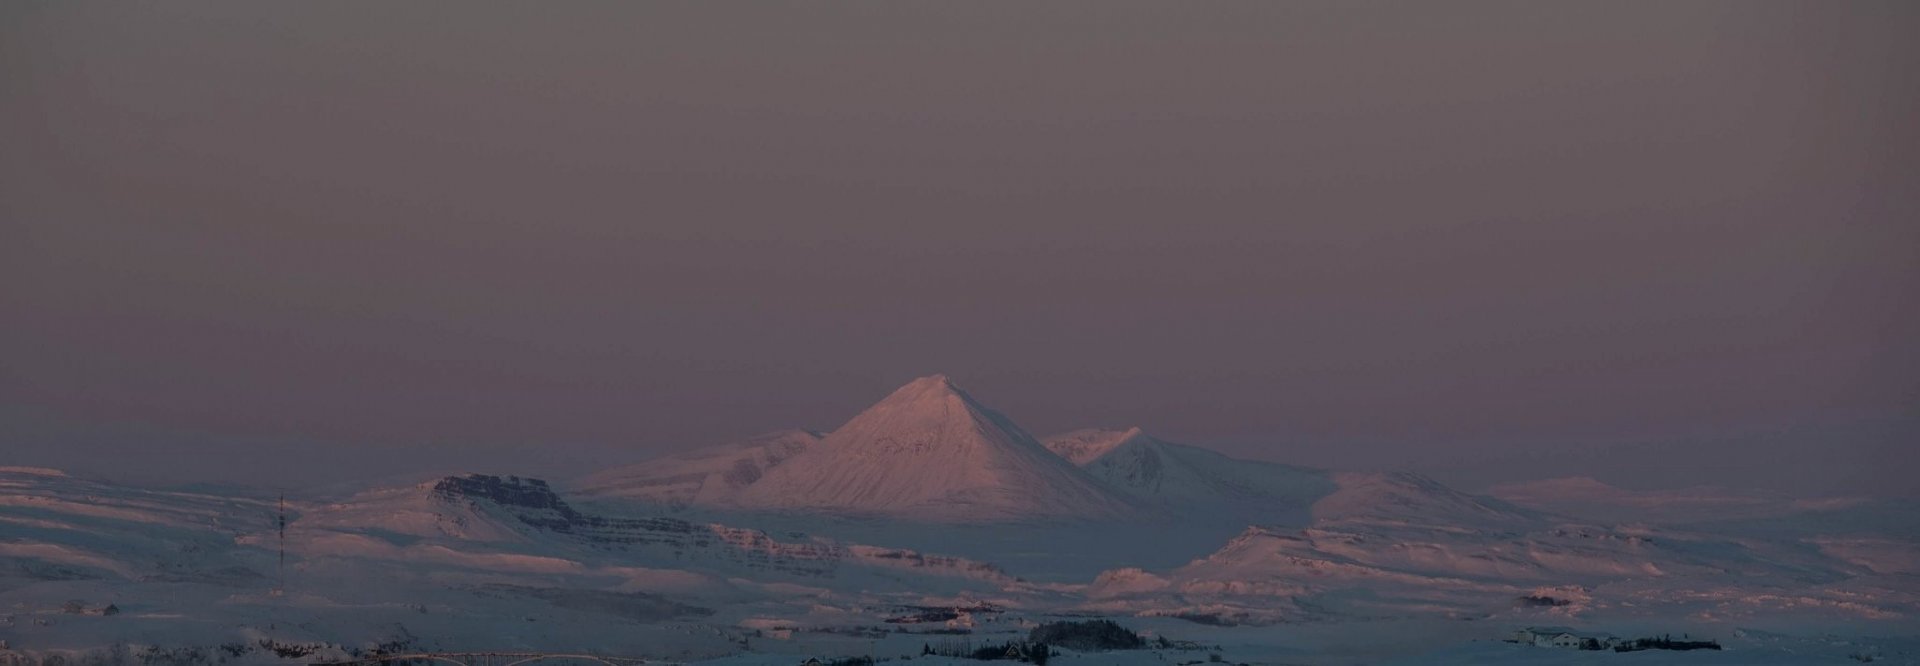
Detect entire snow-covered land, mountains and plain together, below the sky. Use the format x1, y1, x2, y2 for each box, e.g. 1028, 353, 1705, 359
0, 376, 1920, 664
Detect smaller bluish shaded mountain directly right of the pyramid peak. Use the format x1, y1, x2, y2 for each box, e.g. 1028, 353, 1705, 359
1046, 428, 1336, 522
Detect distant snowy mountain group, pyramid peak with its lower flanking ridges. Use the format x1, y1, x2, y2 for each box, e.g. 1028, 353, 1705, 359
572, 376, 1526, 528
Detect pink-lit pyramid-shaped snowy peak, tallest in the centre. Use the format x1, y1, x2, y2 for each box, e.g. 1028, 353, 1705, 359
735, 374, 1129, 522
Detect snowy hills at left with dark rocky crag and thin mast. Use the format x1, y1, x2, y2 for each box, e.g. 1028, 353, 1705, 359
0, 468, 1027, 664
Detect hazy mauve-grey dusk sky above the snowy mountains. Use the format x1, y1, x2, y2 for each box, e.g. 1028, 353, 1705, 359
0, 2, 1920, 495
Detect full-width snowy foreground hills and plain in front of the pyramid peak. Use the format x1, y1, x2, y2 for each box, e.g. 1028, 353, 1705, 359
0, 456, 1920, 664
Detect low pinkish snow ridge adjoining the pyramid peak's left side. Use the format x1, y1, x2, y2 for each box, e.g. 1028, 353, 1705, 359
574, 430, 820, 505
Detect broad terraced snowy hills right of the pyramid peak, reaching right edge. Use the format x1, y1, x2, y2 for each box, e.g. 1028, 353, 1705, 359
1087, 472, 1920, 624
